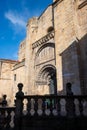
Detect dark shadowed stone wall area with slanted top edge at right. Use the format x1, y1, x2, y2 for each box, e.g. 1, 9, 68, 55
58, 35, 87, 95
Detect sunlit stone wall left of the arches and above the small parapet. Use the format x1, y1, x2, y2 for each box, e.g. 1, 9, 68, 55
25, 6, 53, 94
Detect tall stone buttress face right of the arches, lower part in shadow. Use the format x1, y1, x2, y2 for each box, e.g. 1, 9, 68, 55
54, 0, 80, 94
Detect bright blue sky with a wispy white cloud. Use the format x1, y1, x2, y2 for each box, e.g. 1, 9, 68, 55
0, 0, 53, 60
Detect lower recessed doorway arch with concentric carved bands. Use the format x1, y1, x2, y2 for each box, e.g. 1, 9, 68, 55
37, 64, 57, 94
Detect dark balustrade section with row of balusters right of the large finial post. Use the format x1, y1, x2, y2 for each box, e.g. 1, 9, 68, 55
22, 95, 87, 117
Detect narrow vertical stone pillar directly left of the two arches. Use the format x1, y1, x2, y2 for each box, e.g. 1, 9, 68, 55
25, 17, 38, 95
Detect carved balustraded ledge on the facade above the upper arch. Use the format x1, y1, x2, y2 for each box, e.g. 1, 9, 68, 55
32, 31, 54, 49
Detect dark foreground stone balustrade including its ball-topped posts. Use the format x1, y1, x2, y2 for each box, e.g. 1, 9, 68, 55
0, 83, 87, 130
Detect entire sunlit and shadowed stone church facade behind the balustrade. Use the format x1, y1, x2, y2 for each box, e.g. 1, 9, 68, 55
0, 0, 87, 102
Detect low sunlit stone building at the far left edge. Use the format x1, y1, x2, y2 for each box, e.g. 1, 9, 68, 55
0, 60, 16, 103
